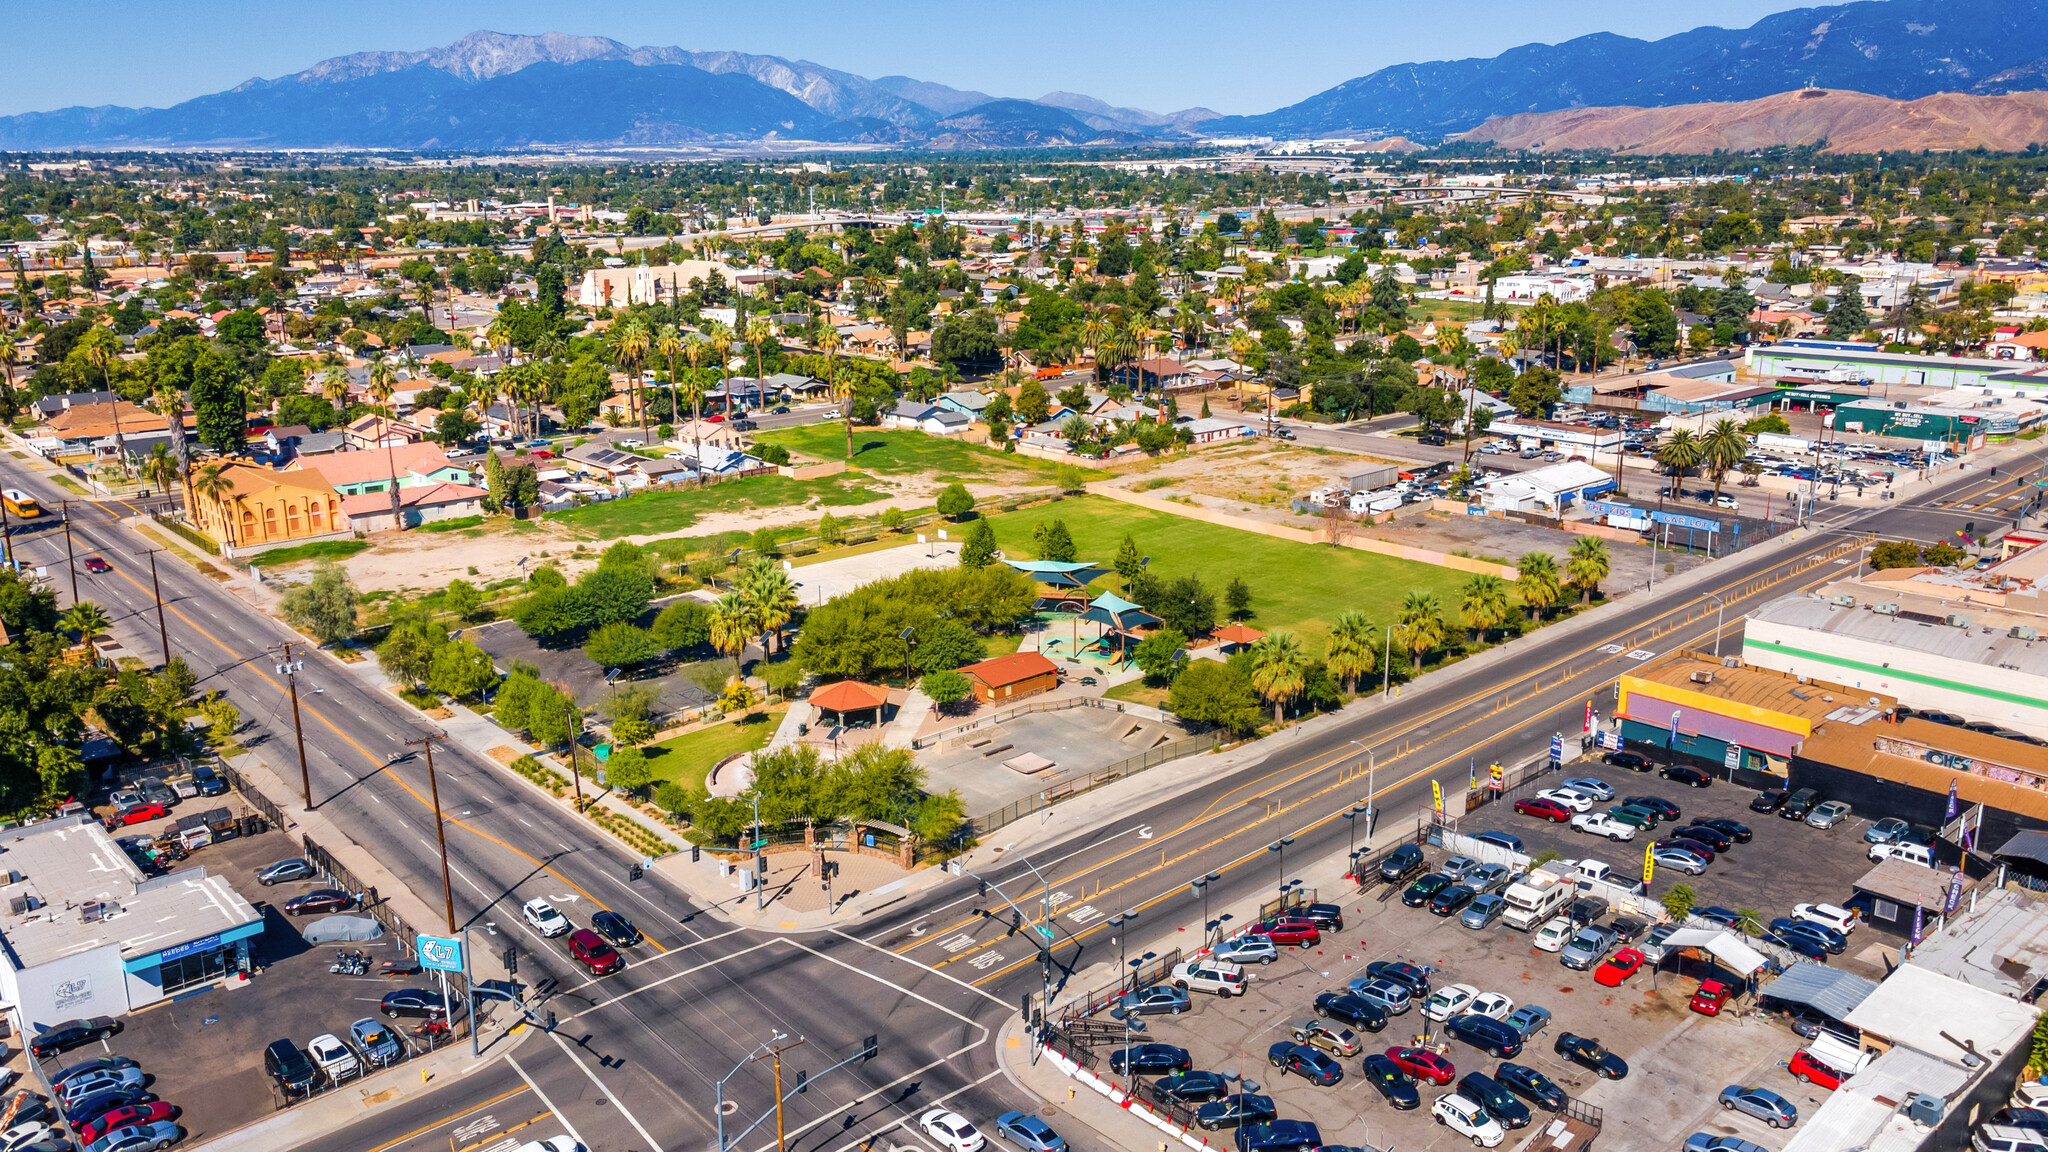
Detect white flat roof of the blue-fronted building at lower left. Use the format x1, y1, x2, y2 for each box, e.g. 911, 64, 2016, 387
0, 816, 262, 968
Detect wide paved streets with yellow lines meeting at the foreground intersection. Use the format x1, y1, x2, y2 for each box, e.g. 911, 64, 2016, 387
0, 451, 2042, 1152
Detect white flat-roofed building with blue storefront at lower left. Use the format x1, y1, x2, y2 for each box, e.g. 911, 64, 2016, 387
0, 816, 262, 1033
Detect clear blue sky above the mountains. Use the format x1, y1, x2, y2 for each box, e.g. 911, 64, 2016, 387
0, 0, 1826, 115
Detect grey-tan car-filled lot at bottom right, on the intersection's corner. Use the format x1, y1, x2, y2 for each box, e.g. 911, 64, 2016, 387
1096, 832, 1859, 1150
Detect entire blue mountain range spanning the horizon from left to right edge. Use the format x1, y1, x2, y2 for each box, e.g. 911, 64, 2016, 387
0, 0, 2048, 152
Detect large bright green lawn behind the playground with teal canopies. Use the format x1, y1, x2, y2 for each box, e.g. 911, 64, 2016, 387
989, 496, 1470, 656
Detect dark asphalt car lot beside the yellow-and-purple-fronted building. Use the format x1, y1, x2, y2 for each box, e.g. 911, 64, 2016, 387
1458, 756, 1884, 978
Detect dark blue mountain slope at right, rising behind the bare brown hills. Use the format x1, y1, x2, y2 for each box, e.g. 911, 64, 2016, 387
1202, 0, 2048, 137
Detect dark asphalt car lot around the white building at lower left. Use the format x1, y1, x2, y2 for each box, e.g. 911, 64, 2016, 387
45, 819, 456, 1142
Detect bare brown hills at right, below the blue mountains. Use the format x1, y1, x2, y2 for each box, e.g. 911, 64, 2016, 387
1458, 88, 2048, 154
